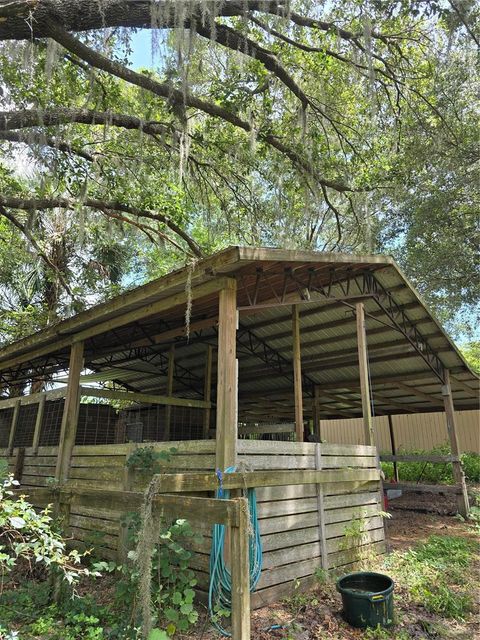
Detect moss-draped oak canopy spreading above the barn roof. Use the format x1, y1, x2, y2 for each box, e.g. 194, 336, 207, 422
0, 0, 480, 340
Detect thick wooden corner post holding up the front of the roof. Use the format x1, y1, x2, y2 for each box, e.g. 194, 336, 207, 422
216, 279, 238, 470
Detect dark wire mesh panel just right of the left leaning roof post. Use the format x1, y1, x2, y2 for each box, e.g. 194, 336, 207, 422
75, 402, 118, 444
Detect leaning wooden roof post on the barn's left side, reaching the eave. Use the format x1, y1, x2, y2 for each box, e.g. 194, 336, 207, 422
55, 342, 83, 482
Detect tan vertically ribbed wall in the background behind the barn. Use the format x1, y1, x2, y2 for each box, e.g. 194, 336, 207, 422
321, 410, 480, 453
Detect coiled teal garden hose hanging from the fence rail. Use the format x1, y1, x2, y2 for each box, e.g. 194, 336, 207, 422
208, 467, 262, 637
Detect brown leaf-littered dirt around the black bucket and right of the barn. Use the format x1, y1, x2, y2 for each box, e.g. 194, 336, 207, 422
178, 496, 480, 640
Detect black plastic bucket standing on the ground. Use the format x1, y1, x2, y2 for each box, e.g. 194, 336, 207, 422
337, 571, 394, 629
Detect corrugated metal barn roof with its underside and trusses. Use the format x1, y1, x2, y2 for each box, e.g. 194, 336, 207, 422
0, 247, 478, 420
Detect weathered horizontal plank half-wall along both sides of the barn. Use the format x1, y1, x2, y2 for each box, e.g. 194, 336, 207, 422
0, 440, 384, 607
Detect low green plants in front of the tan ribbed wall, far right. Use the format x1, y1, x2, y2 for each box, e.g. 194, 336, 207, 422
382, 444, 480, 484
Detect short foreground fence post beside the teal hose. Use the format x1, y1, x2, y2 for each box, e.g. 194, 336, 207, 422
230, 498, 250, 640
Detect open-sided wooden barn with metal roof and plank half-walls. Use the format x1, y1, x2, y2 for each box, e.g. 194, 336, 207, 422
0, 247, 478, 632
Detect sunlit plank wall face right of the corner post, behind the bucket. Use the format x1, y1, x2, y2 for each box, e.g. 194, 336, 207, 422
238, 440, 385, 607
